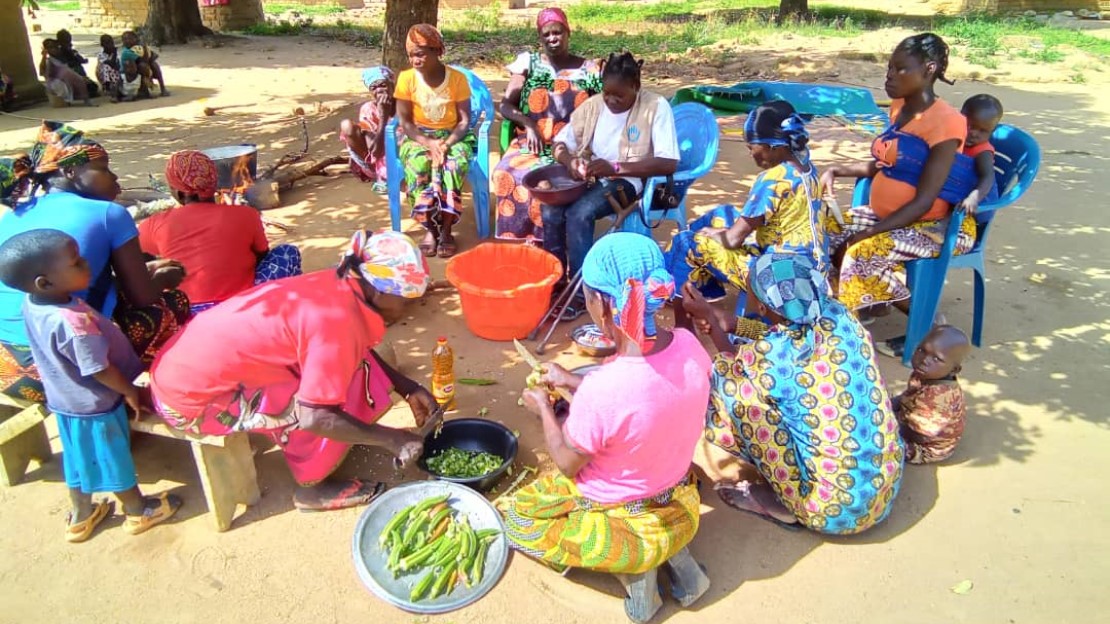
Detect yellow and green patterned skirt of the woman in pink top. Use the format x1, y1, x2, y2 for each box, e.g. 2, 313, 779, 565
497, 473, 702, 574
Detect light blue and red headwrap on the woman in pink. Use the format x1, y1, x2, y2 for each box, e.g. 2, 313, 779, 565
582, 232, 675, 349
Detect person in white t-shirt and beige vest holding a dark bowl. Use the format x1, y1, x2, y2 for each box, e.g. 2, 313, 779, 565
542, 52, 679, 320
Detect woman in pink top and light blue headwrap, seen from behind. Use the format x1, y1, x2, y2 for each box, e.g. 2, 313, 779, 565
501, 233, 710, 622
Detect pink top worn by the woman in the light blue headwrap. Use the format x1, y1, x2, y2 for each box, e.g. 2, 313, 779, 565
564, 330, 712, 503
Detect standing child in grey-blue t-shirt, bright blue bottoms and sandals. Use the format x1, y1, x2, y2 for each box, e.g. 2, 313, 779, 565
0, 230, 181, 543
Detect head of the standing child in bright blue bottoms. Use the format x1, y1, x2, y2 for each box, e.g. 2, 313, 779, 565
0, 230, 92, 300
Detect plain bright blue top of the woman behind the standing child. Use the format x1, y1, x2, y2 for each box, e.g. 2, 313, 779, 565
0, 192, 138, 345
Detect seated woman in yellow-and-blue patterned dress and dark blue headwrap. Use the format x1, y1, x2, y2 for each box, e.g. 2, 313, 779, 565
667, 101, 828, 329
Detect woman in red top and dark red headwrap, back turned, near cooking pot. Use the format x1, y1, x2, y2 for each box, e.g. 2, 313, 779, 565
139, 150, 301, 314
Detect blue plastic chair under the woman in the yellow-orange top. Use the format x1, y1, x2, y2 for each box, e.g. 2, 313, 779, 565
385, 66, 494, 239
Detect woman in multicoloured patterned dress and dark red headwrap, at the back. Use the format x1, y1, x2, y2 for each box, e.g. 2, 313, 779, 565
493, 7, 602, 243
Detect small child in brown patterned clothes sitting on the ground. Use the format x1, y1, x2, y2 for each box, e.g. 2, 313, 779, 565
891, 325, 971, 464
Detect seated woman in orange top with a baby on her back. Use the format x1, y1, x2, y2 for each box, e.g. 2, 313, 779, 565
821, 32, 976, 337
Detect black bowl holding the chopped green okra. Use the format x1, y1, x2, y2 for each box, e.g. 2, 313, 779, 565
418, 419, 517, 492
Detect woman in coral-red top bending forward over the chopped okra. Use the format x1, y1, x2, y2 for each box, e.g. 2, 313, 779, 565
150, 231, 435, 510
